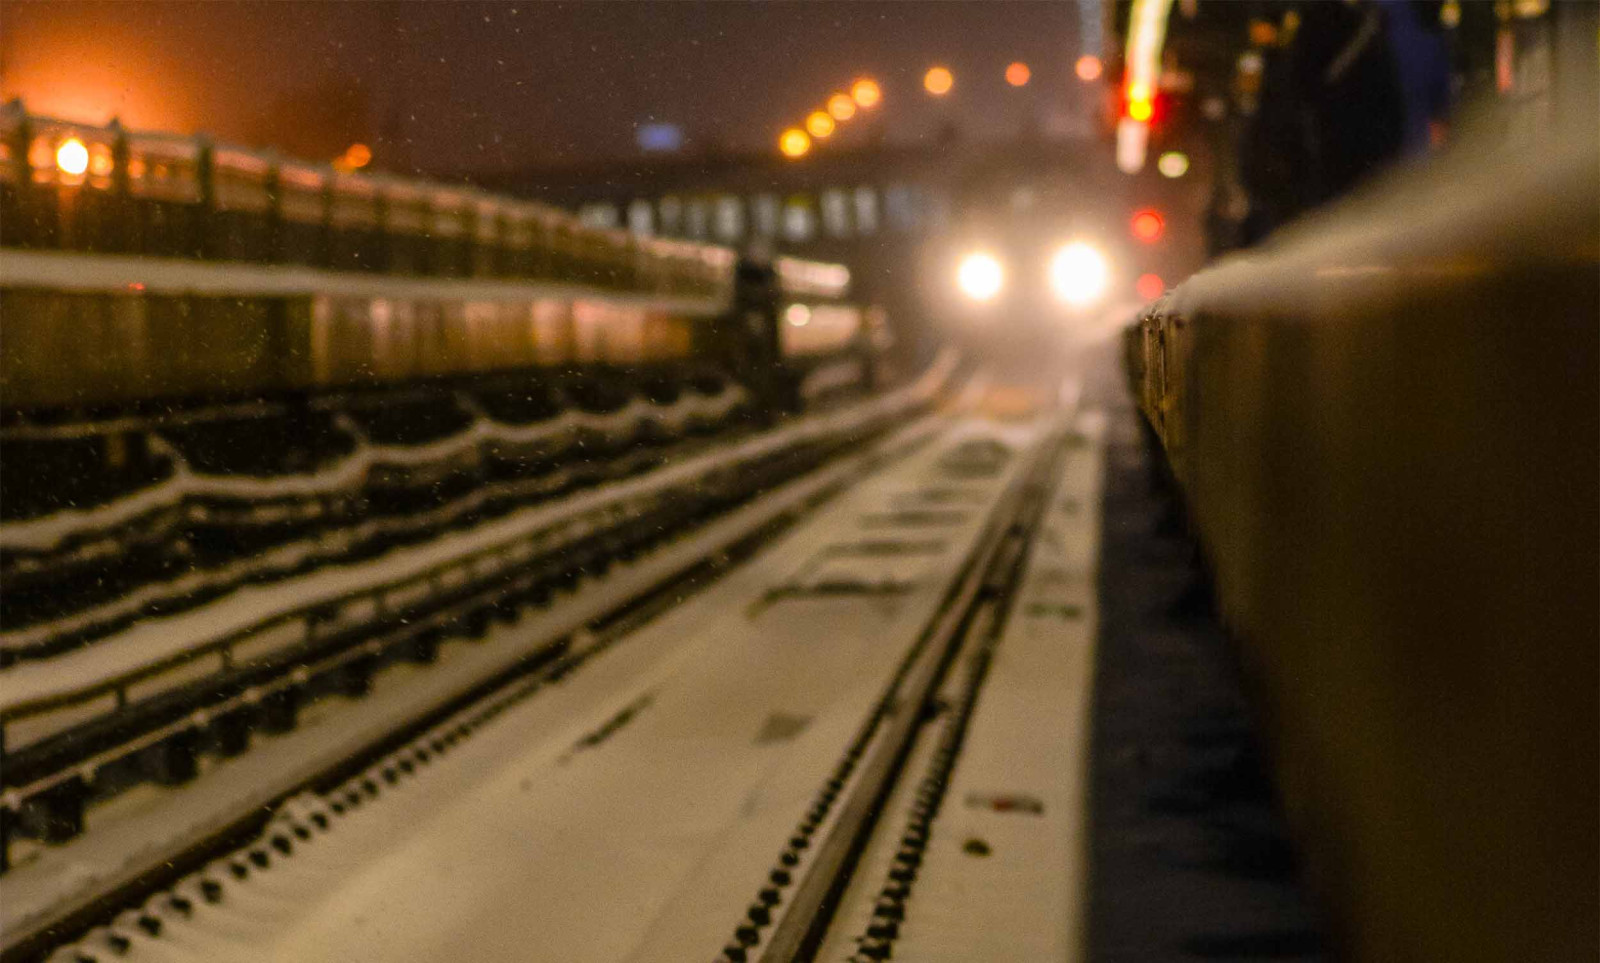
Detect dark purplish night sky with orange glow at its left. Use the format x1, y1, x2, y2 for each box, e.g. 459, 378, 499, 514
0, 0, 1080, 171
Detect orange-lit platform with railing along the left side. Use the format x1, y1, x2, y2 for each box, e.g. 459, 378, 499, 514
0, 101, 882, 424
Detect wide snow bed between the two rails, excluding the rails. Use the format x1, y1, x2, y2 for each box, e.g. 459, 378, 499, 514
53, 401, 1021, 963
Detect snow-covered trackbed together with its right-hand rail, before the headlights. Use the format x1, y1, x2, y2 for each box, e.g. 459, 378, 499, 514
25, 385, 1062, 961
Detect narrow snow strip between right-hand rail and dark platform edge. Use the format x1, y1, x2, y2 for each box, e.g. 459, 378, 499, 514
880, 411, 1104, 963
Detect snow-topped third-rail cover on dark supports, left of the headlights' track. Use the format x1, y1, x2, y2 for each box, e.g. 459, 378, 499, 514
0, 348, 954, 863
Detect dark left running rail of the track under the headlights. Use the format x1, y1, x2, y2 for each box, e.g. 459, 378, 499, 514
0, 365, 949, 963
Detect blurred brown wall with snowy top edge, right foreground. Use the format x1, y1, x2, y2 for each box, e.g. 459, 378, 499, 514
1130, 114, 1600, 961
